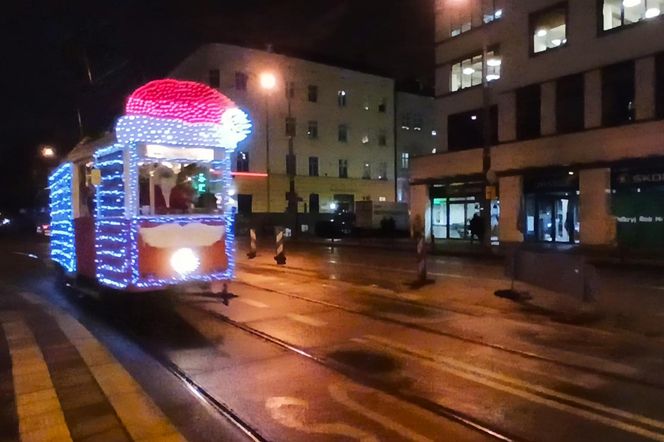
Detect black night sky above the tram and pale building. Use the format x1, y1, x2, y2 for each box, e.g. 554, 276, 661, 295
0, 0, 433, 209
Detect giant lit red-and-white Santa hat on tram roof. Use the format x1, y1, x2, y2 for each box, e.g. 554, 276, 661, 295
116, 79, 251, 149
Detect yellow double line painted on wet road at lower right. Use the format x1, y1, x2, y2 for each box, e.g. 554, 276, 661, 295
355, 335, 664, 442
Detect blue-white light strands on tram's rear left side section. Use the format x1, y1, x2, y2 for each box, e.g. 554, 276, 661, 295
48, 163, 76, 273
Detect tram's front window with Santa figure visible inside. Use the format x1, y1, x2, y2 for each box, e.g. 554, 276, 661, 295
138, 161, 223, 215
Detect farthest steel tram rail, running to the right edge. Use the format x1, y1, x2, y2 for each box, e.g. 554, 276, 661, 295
234, 281, 664, 390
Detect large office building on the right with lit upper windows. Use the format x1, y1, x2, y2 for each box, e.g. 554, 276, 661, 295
411, 0, 664, 248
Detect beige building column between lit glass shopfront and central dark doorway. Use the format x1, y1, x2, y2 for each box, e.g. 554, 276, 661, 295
498, 176, 524, 243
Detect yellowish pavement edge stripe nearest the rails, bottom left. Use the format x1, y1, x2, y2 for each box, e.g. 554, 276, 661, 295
21, 292, 186, 441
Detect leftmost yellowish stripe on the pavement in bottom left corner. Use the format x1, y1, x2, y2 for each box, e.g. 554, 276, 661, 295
2, 320, 72, 442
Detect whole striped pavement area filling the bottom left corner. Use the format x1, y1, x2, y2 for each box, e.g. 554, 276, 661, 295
0, 288, 185, 442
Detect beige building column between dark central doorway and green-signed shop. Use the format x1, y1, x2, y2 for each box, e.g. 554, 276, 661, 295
579, 168, 616, 246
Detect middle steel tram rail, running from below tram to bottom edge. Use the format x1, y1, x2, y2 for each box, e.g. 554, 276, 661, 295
187, 304, 525, 442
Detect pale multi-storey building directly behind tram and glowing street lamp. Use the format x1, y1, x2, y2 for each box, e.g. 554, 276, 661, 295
171, 44, 395, 218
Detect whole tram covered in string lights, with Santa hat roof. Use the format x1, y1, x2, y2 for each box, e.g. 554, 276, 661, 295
49, 79, 251, 291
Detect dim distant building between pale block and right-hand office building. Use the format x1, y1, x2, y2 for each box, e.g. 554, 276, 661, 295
396, 91, 438, 203
